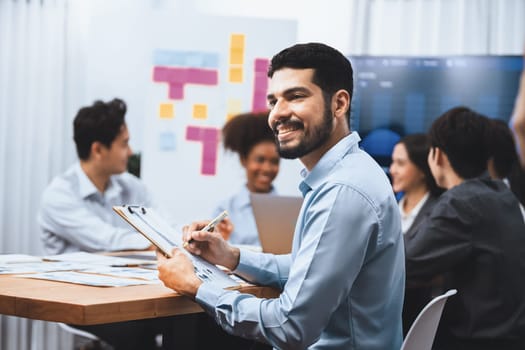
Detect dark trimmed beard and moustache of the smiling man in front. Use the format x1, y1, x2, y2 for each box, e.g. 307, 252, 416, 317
274, 105, 334, 159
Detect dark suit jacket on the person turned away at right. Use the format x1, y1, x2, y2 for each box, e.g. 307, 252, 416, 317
405, 175, 525, 350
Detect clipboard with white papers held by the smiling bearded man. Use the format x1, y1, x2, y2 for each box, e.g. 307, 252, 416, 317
113, 205, 240, 289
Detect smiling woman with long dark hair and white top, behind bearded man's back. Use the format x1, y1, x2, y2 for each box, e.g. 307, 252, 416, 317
390, 134, 443, 335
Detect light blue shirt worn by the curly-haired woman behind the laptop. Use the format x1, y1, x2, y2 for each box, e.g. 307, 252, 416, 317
212, 185, 276, 247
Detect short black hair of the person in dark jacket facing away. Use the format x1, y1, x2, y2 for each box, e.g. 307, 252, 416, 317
429, 107, 489, 179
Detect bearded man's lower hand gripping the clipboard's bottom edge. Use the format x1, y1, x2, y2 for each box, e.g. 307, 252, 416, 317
157, 248, 202, 298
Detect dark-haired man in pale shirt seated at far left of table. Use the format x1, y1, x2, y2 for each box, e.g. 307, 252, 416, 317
38, 99, 174, 350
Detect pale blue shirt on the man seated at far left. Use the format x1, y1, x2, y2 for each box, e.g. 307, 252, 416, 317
38, 163, 152, 254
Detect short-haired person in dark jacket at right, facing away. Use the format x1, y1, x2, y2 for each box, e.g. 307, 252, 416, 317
406, 107, 525, 350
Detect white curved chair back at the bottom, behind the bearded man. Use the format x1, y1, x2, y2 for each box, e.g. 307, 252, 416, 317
401, 289, 457, 350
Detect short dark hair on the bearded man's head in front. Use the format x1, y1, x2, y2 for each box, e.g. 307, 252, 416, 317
268, 43, 354, 126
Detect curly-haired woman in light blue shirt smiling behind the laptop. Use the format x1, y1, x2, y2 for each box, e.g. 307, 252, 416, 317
212, 112, 280, 246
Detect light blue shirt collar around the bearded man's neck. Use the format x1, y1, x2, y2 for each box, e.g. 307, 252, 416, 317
299, 131, 361, 197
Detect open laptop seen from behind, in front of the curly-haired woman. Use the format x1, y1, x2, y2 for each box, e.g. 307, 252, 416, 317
250, 193, 303, 254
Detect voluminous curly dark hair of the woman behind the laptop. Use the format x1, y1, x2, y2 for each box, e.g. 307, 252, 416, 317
222, 112, 275, 158
